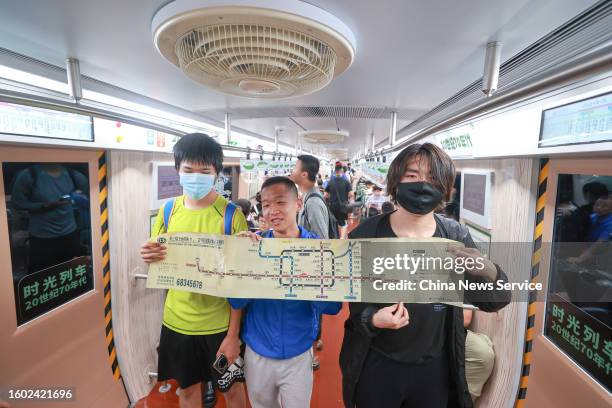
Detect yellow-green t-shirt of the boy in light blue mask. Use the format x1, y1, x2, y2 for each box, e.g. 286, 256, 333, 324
151, 196, 248, 335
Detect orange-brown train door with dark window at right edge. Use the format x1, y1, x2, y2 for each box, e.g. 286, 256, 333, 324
525, 158, 612, 408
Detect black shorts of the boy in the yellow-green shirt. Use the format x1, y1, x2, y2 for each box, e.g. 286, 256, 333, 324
157, 324, 227, 389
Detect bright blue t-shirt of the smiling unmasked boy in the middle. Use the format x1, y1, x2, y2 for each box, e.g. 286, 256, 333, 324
228, 227, 342, 359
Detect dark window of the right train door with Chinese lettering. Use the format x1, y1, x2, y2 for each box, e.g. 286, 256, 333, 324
544, 174, 612, 391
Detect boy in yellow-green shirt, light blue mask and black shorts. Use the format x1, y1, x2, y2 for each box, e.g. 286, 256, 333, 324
140, 133, 248, 408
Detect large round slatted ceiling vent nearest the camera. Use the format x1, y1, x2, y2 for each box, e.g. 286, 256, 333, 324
151, 0, 355, 98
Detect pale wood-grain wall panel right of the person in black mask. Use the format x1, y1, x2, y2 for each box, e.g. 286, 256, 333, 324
456, 159, 537, 408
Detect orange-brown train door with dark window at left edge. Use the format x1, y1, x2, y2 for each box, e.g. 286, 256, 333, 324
0, 146, 128, 407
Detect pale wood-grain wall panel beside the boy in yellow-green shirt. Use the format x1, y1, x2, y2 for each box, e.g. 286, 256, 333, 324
108, 151, 173, 401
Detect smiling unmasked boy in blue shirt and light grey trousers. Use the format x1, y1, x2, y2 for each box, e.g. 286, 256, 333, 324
229, 177, 342, 408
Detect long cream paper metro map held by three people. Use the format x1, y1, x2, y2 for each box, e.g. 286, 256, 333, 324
147, 233, 470, 305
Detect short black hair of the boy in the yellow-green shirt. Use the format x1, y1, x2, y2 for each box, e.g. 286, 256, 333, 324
172, 133, 223, 174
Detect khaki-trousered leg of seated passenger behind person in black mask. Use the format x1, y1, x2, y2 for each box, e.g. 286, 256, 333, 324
463, 309, 495, 401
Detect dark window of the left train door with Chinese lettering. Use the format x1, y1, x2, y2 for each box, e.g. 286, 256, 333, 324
2, 162, 93, 325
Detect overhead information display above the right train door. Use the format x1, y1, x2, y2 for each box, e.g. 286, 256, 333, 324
539, 93, 612, 147
